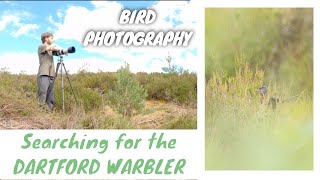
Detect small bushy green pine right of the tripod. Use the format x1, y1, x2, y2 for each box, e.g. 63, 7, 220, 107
107, 64, 147, 116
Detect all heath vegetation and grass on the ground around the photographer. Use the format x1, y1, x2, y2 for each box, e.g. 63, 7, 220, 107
0, 66, 197, 129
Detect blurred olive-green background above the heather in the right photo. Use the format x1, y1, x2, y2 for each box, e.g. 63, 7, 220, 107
205, 8, 313, 89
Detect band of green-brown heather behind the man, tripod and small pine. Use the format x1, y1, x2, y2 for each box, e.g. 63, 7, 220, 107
0, 67, 197, 112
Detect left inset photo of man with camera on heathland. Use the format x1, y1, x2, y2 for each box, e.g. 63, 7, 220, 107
0, 1, 198, 129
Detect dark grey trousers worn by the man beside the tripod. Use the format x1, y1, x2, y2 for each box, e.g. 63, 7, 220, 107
38, 76, 54, 112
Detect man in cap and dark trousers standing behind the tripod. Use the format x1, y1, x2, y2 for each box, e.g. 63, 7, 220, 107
38, 32, 62, 112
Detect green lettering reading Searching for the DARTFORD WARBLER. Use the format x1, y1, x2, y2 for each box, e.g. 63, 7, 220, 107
13, 133, 187, 175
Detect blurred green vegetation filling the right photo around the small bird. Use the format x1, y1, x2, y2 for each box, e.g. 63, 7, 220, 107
205, 9, 313, 170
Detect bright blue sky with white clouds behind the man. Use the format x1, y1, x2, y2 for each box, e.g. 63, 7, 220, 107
0, 1, 199, 74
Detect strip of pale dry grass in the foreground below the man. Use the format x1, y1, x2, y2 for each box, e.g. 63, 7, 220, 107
0, 98, 197, 129
